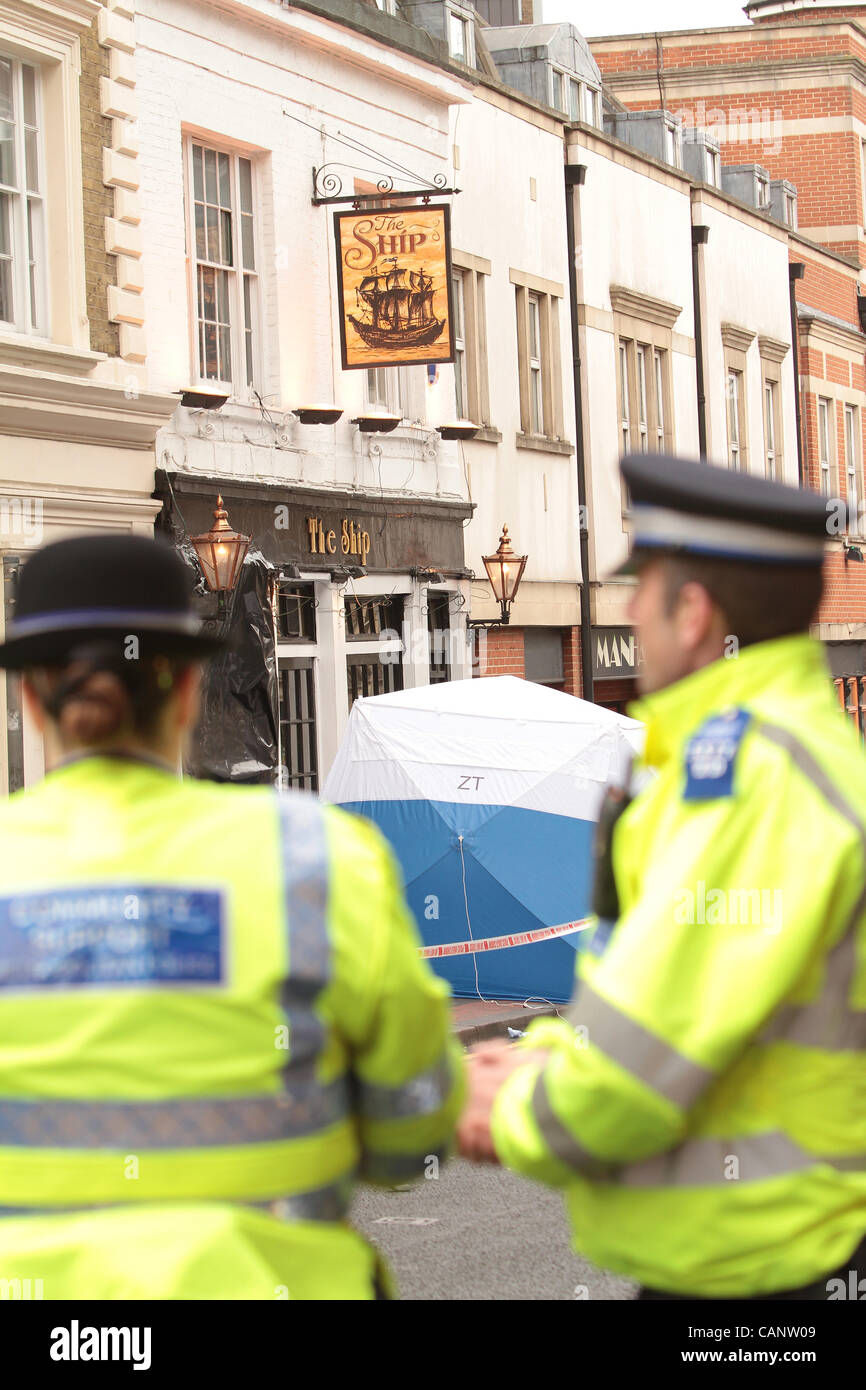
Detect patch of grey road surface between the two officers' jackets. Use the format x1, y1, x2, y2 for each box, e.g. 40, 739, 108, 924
352, 1159, 637, 1301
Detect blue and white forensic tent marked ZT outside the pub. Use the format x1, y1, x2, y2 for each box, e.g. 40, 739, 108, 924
324, 676, 644, 1001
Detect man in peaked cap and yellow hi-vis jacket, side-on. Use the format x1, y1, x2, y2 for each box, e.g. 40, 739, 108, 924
460, 455, 866, 1300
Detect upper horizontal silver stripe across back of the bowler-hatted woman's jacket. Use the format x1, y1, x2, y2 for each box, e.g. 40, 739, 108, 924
0, 1069, 348, 1154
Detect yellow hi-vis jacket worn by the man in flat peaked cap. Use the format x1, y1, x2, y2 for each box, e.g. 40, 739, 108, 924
493, 637, 866, 1297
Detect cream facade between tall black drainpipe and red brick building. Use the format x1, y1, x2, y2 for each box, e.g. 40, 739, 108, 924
567, 129, 798, 705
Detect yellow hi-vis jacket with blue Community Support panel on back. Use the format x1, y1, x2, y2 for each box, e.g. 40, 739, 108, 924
0, 758, 461, 1300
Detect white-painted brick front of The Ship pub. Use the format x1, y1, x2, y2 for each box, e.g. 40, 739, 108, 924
136, 0, 470, 787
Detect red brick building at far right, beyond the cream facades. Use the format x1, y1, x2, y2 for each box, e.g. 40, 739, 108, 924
591, 0, 866, 720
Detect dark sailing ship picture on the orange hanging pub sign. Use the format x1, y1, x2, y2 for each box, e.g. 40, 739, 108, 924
346, 256, 446, 349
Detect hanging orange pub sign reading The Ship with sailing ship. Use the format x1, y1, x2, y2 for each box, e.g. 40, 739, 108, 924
334, 206, 455, 370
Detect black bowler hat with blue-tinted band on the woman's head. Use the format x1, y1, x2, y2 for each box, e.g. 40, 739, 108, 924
0, 535, 222, 670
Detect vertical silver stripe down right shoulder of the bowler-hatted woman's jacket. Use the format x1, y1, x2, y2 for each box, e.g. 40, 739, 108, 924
278, 792, 331, 1067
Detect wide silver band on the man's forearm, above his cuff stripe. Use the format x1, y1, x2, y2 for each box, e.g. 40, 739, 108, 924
567, 980, 714, 1111
